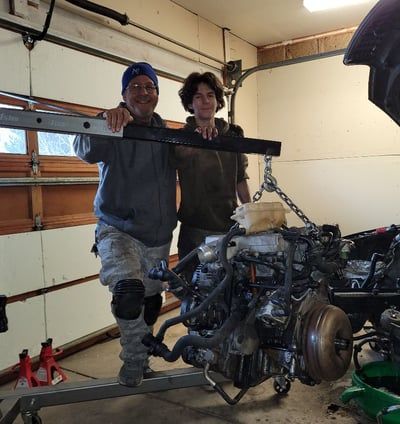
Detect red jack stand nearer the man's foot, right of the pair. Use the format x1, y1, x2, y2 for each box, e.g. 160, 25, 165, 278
36, 339, 67, 386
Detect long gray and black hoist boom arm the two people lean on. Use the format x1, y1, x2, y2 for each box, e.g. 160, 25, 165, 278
0, 108, 281, 156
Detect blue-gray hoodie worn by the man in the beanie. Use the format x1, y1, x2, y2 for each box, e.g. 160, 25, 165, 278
74, 114, 176, 247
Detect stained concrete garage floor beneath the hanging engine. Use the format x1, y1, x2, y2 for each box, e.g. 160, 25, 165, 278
0, 311, 372, 424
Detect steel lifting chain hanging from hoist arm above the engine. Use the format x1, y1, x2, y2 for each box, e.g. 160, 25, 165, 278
253, 155, 318, 232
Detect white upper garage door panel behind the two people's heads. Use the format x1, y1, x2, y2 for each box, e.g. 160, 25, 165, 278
30, 41, 191, 121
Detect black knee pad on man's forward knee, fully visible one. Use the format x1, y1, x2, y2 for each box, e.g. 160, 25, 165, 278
111, 279, 144, 320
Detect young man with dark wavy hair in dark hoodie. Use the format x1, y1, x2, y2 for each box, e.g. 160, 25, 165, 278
173, 72, 251, 270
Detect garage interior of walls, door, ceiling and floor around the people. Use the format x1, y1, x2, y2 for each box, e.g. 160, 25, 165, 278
0, 0, 400, 424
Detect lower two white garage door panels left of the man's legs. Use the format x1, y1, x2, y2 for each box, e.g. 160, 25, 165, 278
0, 225, 114, 369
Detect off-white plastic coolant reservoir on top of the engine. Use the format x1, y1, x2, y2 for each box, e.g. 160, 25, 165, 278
231, 202, 289, 234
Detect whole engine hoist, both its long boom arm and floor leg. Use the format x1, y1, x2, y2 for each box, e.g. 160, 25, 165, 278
0, 108, 266, 424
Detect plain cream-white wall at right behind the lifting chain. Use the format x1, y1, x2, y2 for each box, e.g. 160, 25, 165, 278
257, 56, 400, 234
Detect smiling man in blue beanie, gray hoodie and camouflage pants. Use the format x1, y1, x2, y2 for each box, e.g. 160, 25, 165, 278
74, 62, 176, 386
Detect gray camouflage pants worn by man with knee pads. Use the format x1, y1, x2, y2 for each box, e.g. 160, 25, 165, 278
96, 223, 170, 363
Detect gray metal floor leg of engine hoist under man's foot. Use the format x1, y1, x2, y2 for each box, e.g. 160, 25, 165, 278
0, 368, 226, 424
